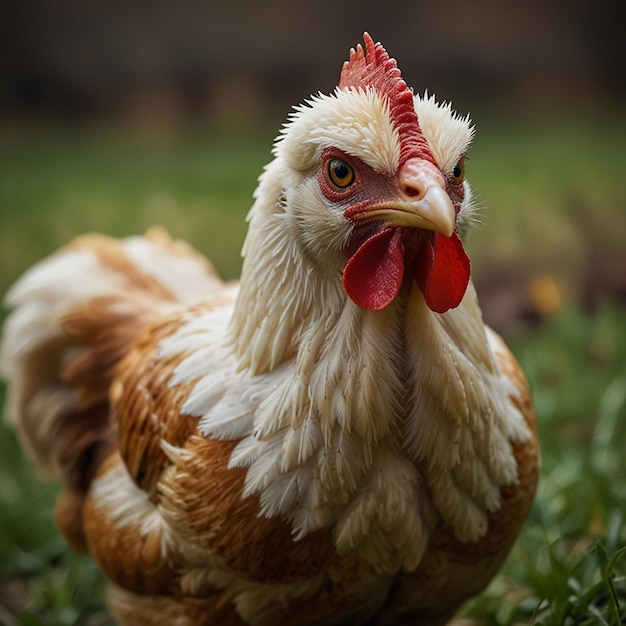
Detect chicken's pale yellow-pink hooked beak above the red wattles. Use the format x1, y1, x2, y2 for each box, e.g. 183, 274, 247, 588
353, 158, 456, 237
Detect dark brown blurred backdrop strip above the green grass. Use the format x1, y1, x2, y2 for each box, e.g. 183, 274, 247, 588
0, 0, 625, 120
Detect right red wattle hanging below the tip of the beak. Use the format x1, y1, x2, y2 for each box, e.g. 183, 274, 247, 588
414, 232, 470, 313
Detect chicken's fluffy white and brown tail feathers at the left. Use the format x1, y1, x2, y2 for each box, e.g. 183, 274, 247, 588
0, 230, 223, 493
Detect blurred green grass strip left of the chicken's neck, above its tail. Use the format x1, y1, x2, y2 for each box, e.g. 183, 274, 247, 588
0, 122, 271, 287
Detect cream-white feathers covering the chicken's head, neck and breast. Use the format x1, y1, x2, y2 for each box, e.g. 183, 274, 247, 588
149, 80, 528, 572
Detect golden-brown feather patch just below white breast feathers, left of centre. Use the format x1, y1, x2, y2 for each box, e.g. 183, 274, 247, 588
161, 436, 334, 583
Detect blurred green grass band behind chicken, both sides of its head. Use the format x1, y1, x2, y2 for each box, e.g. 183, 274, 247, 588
0, 110, 626, 292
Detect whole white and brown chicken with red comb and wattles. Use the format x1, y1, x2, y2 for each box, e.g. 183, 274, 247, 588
1, 34, 539, 626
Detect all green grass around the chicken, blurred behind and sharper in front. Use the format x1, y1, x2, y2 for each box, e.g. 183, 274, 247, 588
0, 109, 626, 626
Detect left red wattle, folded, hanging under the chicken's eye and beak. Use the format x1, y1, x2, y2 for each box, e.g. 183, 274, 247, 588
343, 228, 404, 310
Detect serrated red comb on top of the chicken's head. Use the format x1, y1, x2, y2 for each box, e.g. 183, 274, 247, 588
339, 33, 435, 164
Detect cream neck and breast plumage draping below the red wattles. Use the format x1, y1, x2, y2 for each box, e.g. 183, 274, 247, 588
224, 169, 527, 568
